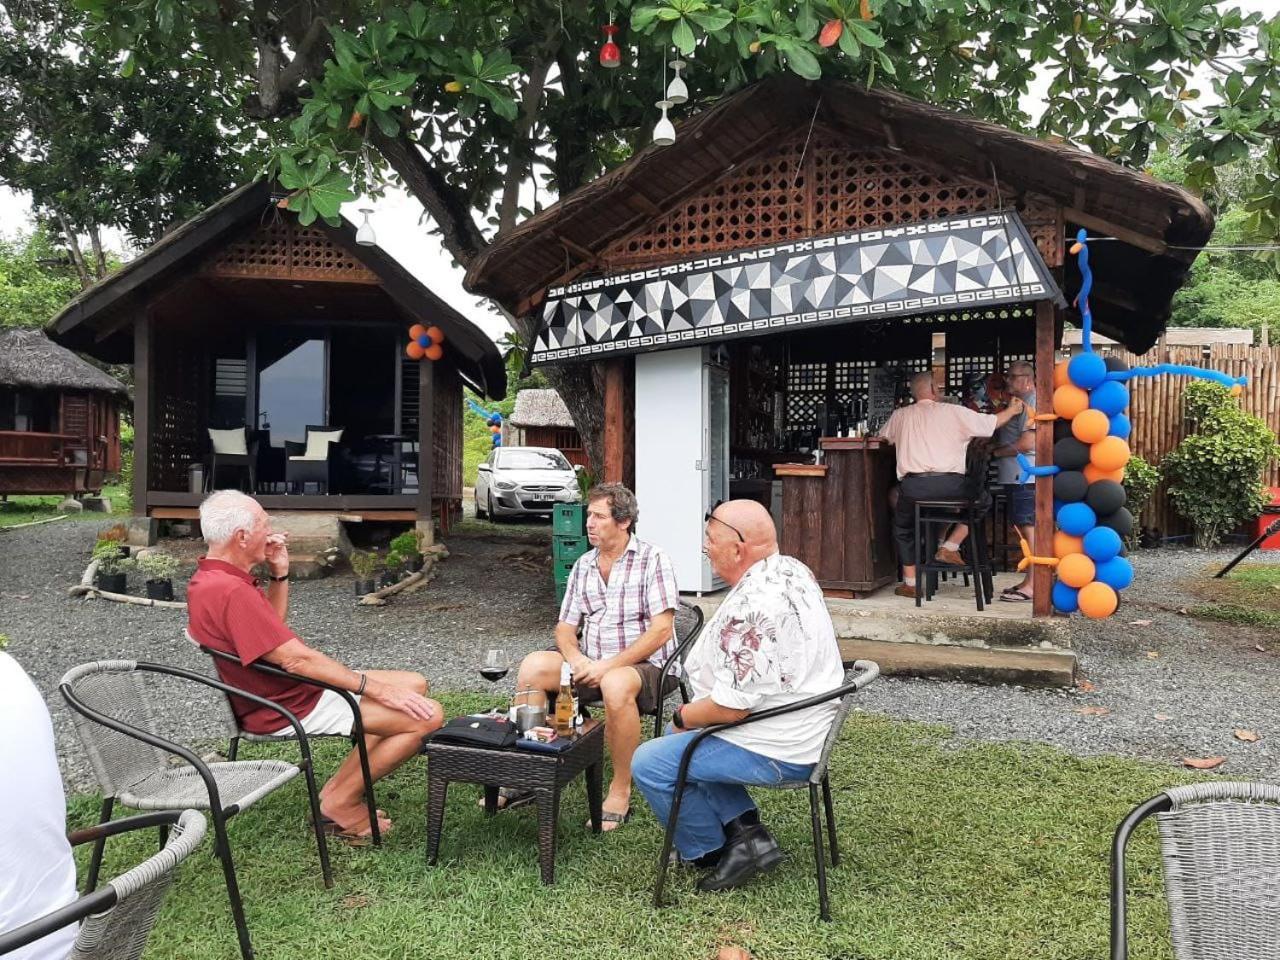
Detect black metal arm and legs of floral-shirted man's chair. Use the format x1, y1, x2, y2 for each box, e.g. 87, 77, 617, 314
653, 660, 879, 920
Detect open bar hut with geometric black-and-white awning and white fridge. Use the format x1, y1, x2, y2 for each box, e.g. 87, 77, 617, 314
467, 77, 1213, 616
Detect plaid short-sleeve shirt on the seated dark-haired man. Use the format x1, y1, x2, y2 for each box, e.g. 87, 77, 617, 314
559, 536, 680, 667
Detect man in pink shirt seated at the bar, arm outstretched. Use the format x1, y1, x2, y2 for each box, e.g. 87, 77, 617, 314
881, 372, 1023, 596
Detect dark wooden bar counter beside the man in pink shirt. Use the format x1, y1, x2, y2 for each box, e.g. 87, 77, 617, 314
774, 436, 897, 595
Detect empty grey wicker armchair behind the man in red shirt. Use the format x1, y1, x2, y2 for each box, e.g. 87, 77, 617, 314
58, 660, 333, 960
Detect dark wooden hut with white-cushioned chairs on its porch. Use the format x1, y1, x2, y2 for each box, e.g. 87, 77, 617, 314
50, 180, 506, 536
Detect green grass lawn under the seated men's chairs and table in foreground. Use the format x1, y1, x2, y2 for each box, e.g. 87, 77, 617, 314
70, 696, 1188, 960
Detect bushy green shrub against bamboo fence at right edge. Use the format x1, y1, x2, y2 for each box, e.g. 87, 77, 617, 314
1161, 381, 1280, 547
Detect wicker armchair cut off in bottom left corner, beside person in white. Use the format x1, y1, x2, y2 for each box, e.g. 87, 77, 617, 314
0, 810, 205, 960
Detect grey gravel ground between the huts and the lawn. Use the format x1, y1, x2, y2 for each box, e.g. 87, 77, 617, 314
0, 521, 1280, 786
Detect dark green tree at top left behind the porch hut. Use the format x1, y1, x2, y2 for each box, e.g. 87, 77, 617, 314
0, 0, 262, 285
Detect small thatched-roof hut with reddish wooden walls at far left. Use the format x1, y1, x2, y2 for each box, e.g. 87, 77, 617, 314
0, 330, 127, 497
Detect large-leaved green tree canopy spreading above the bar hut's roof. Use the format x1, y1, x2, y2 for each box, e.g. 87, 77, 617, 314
78, 0, 1280, 463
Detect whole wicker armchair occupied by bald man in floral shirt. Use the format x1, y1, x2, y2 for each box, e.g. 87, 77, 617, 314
653, 660, 879, 920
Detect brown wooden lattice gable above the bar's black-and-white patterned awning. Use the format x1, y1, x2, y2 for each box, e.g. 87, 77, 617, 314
602, 128, 1062, 273
